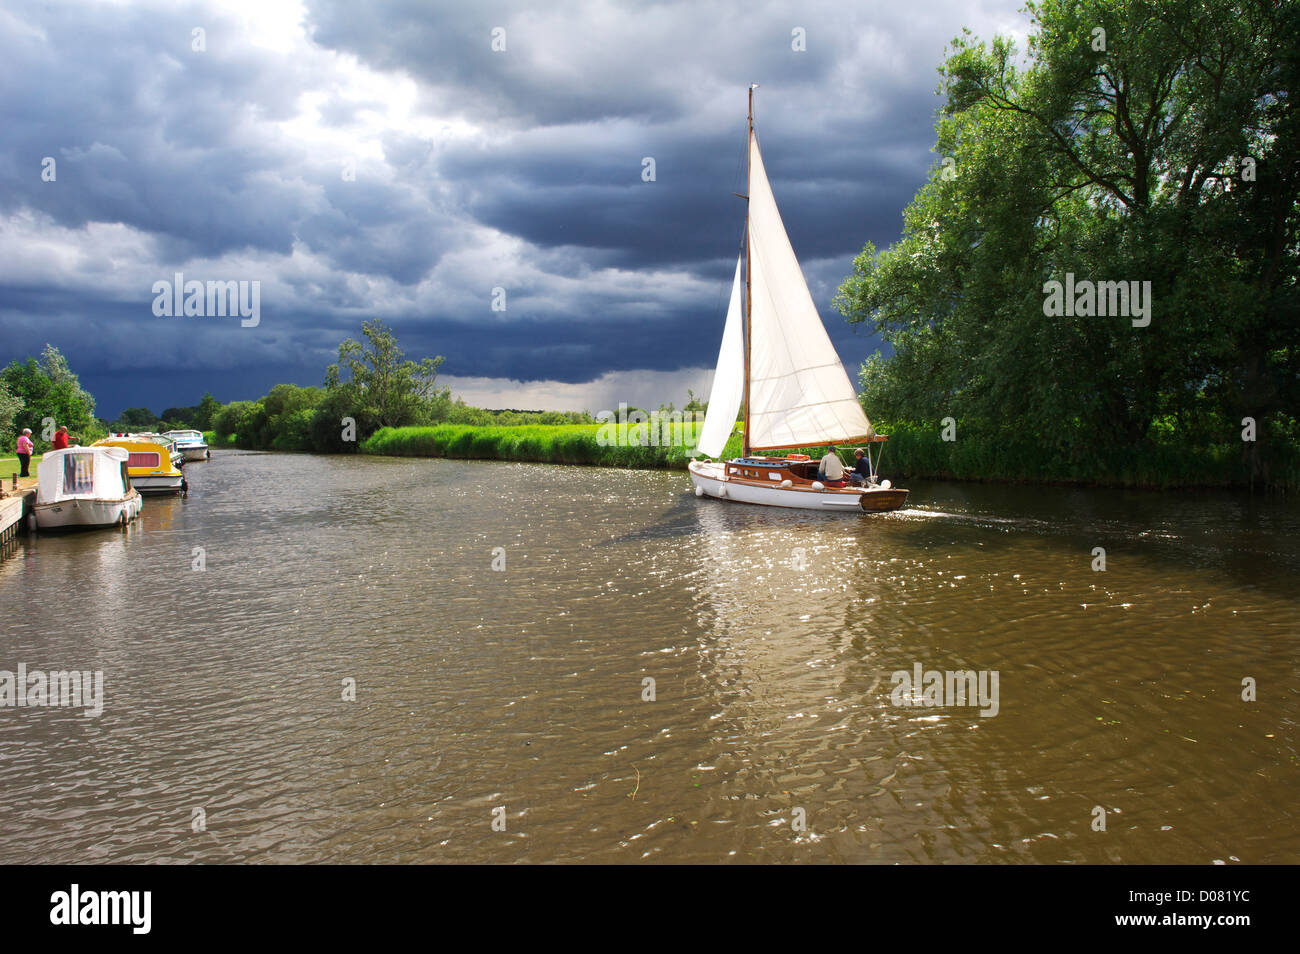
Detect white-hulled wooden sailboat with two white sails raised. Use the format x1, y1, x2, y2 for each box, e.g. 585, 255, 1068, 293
689, 86, 907, 512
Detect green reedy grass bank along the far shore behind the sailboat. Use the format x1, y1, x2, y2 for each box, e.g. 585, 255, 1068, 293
361, 424, 1300, 490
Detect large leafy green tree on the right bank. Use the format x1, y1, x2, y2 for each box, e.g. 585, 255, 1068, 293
836, 0, 1300, 472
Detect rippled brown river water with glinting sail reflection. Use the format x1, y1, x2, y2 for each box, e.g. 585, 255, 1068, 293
0, 452, 1300, 863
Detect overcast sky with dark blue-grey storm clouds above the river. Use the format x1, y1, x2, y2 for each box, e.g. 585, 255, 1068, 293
0, 0, 1028, 419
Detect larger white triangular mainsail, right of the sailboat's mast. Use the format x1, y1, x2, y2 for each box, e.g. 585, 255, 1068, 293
748, 136, 871, 448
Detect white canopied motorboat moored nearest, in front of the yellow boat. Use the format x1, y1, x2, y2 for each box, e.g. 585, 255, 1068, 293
33, 446, 143, 530
